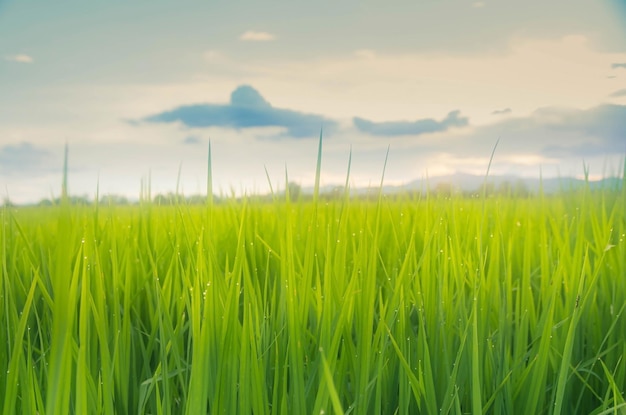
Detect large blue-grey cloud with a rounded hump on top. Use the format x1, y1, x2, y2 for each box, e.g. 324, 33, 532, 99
145, 85, 336, 138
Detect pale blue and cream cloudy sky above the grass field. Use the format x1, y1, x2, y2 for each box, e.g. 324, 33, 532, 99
0, 0, 626, 203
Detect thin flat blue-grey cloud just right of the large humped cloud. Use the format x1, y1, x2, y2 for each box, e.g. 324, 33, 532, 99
353, 111, 468, 136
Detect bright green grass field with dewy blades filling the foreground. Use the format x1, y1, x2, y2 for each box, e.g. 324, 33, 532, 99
0, 154, 626, 415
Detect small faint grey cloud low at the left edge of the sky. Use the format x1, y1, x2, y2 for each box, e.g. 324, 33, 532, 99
0, 142, 50, 175
